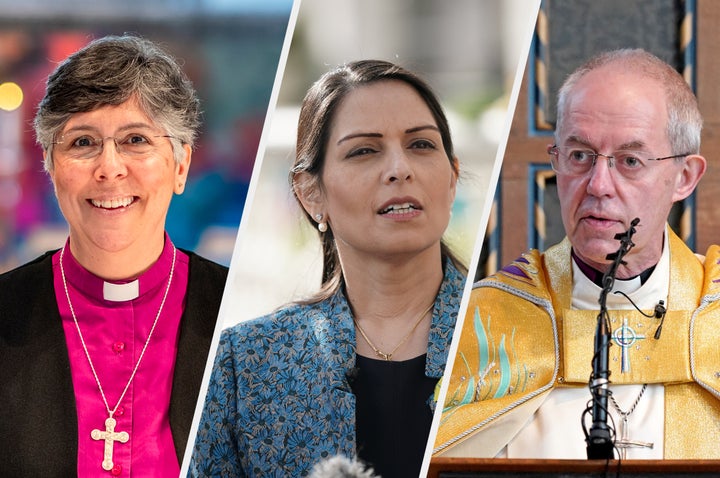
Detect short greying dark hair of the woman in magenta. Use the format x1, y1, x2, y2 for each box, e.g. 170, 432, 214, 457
34, 35, 201, 172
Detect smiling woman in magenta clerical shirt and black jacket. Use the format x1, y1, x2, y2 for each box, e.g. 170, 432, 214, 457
0, 36, 227, 477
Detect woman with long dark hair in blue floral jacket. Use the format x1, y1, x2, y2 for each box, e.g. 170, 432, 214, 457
190, 60, 466, 477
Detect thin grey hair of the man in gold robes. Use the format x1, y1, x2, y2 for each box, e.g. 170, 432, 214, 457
555, 48, 703, 154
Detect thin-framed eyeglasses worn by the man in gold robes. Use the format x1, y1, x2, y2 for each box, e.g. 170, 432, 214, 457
548, 145, 691, 179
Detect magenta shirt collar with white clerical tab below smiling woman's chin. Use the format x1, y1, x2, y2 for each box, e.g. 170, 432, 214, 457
58, 234, 173, 302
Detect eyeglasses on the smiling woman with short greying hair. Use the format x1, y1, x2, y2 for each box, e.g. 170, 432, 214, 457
52, 133, 174, 159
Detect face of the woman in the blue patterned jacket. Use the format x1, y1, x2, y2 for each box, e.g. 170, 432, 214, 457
303, 80, 457, 266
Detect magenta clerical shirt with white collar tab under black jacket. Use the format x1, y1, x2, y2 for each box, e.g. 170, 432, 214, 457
53, 235, 188, 478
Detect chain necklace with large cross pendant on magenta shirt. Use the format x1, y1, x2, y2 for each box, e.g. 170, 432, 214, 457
60, 245, 177, 471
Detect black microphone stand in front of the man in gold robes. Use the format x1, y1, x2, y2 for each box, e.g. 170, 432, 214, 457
585, 217, 640, 460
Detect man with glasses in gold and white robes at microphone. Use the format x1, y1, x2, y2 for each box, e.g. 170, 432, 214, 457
435, 50, 720, 459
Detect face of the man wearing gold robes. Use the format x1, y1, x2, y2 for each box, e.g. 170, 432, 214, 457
557, 64, 704, 277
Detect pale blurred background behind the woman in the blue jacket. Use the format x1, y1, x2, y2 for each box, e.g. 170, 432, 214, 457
220, 0, 538, 325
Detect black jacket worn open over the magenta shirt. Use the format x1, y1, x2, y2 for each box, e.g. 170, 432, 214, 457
0, 251, 227, 477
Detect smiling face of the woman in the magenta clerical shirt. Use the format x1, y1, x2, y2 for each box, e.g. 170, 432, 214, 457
50, 99, 191, 271
